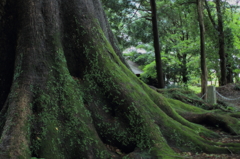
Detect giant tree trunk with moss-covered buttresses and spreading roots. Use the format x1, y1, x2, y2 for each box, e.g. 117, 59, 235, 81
0, 0, 240, 159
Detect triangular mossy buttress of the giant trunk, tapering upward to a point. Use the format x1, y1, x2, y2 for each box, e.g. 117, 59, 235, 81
26, 29, 108, 159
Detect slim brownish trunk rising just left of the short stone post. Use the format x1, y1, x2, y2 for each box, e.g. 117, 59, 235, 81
197, 0, 207, 99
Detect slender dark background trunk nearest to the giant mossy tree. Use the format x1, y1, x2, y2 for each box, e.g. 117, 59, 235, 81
150, 0, 164, 88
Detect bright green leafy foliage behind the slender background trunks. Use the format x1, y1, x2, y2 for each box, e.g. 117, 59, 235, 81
103, 0, 240, 84
